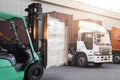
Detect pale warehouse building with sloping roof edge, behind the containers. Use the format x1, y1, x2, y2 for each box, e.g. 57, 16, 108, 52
0, 0, 120, 30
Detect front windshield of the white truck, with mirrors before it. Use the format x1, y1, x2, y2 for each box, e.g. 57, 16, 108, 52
95, 33, 111, 45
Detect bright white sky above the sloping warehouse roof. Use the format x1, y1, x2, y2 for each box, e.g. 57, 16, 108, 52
74, 0, 120, 13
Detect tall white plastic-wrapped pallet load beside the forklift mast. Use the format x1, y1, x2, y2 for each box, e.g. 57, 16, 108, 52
47, 16, 66, 67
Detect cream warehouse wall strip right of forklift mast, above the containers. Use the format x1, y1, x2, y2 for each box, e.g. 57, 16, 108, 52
43, 4, 120, 30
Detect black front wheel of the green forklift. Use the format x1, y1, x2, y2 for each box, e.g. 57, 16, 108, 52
24, 63, 44, 80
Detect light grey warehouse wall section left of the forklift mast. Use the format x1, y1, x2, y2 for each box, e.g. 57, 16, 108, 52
0, 0, 33, 16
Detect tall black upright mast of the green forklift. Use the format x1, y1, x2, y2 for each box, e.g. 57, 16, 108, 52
25, 3, 47, 67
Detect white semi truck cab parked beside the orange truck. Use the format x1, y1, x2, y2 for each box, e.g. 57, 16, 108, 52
68, 21, 112, 67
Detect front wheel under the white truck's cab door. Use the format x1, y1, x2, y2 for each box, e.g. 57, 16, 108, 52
76, 54, 88, 67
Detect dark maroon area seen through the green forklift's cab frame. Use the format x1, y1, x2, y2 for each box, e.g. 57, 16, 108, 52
0, 19, 29, 45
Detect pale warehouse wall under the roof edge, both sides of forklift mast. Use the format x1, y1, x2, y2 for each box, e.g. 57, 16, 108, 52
0, 0, 120, 30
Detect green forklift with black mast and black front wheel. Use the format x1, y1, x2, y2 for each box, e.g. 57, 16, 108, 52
0, 4, 46, 80
